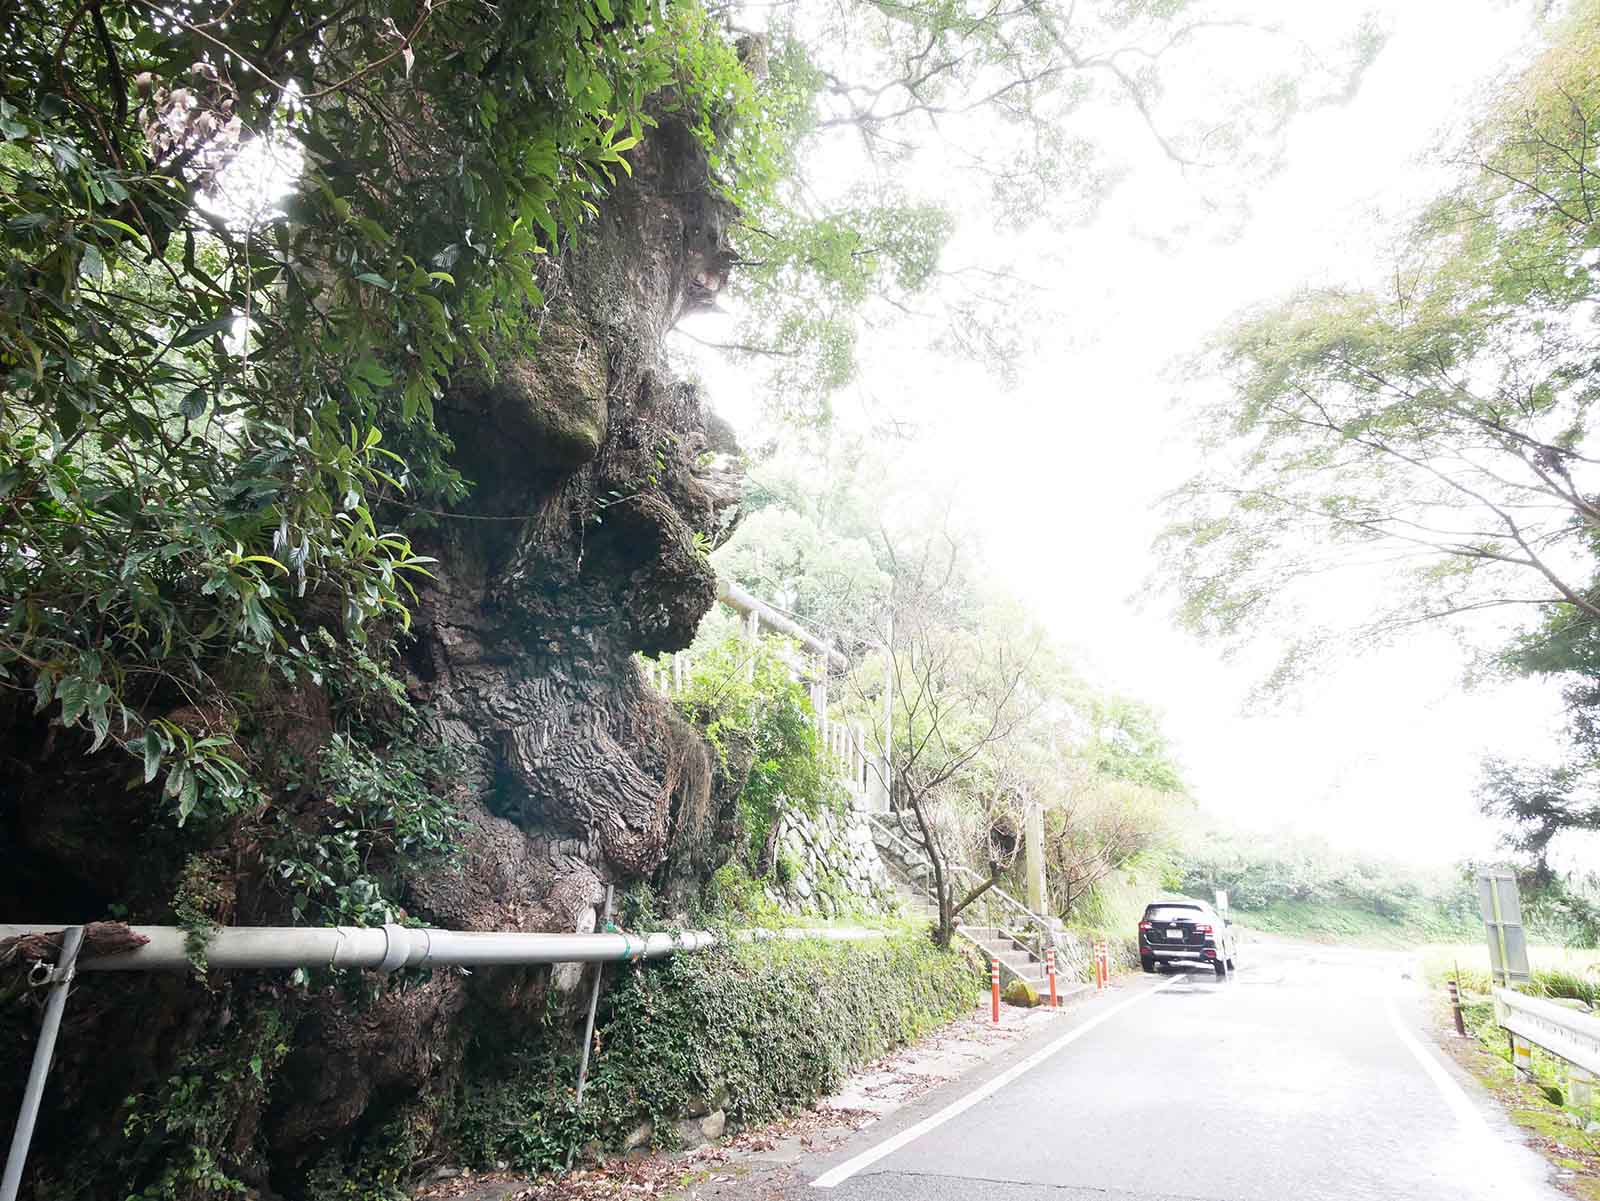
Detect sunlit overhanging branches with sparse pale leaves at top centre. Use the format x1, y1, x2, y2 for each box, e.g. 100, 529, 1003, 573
694, 0, 1382, 419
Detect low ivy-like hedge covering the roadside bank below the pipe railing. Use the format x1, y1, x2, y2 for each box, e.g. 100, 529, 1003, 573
456, 932, 979, 1169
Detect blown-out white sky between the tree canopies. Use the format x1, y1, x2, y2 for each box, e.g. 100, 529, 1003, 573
675, 0, 1557, 862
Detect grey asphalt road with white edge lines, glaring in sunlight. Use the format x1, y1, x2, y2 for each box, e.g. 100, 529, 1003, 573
802, 944, 1562, 1201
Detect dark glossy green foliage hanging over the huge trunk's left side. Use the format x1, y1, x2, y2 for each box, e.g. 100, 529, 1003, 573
0, 0, 773, 820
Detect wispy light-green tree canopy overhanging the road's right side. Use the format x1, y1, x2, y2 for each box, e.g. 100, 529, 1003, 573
1158, 3, 1600, 680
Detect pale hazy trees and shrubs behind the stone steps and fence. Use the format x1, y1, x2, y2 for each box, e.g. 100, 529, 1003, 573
714, 435, 1184, 936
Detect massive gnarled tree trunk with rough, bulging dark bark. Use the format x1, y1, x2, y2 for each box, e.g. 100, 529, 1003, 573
0, 107, 742, 1196
